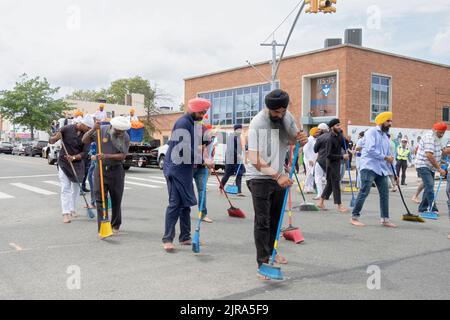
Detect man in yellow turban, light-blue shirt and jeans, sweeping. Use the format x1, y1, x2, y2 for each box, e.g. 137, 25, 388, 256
350, 112, 396, 228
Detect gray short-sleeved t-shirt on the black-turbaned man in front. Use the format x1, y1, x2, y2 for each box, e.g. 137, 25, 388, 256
247, 109, 298, 180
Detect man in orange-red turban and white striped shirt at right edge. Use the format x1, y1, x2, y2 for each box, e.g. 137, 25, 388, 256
416, 122, 450, 212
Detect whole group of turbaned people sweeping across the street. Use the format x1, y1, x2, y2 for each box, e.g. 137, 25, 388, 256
50, 89, 450, 280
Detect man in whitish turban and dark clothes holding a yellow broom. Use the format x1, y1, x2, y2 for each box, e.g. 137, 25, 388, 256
83, 116, 131, 235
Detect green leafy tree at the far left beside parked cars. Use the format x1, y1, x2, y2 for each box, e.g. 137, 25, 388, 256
0, 74, 71, 139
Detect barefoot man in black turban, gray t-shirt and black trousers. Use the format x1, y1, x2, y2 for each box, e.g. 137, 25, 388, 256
247, 89, 308, 280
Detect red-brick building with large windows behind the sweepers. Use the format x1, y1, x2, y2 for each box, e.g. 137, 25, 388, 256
185, 44, 450, 144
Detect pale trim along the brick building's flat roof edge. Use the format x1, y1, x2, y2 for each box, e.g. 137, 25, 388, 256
184, 44, 450, 81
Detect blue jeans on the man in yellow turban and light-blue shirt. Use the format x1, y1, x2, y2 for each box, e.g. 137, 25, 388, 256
352, 169, 389, 219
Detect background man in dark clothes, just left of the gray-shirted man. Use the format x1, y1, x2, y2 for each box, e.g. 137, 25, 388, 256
220, 124, 246, 197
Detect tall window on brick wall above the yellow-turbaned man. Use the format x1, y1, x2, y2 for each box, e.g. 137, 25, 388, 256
370, 75, 391, 121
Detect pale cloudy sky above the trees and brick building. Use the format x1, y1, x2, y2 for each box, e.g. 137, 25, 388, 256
0, 0, 450, 106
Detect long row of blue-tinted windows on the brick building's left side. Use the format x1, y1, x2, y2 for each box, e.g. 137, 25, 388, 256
198, 83, 279, 125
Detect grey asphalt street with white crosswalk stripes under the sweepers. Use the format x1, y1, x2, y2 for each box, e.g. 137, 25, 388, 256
0, 155, 450, 300
